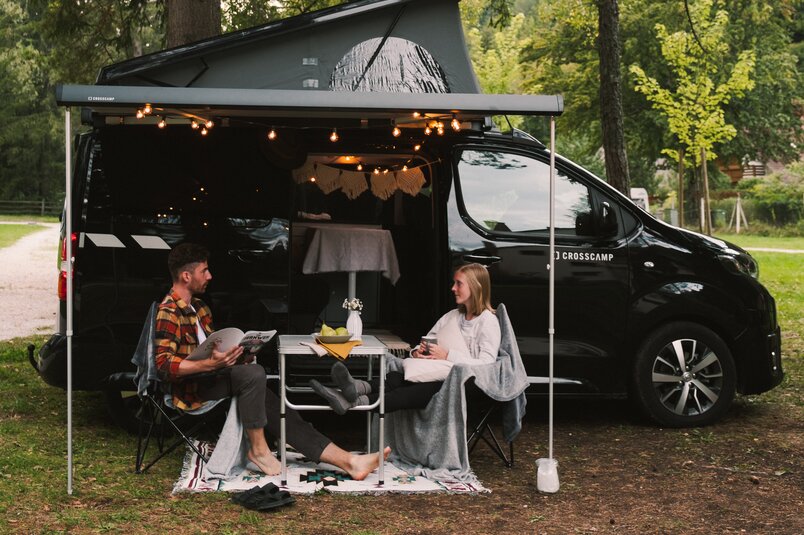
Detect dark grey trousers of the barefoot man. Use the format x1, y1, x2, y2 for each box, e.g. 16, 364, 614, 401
197, 364, 332, 462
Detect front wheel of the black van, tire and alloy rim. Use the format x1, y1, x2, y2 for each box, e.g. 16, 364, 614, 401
631, 322, 737, 427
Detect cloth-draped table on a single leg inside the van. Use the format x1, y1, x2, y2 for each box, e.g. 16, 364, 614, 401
302, 224, 399, 299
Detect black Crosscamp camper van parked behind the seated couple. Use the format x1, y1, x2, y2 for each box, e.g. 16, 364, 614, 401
35, 0, 783, 426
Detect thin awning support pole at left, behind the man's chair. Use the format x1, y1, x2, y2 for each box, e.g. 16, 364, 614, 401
64, 106, 73, 495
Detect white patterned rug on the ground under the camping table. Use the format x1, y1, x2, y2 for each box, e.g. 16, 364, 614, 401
173, 441, 490, 494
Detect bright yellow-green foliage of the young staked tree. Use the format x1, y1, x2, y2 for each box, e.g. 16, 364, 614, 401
630, 0, 755, 165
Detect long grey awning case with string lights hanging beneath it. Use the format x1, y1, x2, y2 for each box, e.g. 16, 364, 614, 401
56, 85, 564, 119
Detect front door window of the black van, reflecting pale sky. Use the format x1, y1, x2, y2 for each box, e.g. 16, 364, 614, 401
457, 149, 594, 236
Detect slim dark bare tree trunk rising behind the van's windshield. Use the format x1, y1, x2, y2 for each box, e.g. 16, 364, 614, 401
597, 0, 630, 197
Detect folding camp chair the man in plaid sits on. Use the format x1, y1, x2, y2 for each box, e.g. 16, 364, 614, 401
131, 303, 223, 474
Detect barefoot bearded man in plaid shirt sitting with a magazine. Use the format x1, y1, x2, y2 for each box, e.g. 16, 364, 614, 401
156, 243, 391, 480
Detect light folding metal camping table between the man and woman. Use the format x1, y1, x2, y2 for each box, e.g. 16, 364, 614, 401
279, 335, 387, 487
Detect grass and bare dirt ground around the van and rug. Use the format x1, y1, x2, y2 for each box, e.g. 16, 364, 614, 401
0, 245, 804, 535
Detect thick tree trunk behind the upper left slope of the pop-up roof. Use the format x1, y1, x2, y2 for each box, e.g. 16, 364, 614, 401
167, 0, 221, 48
